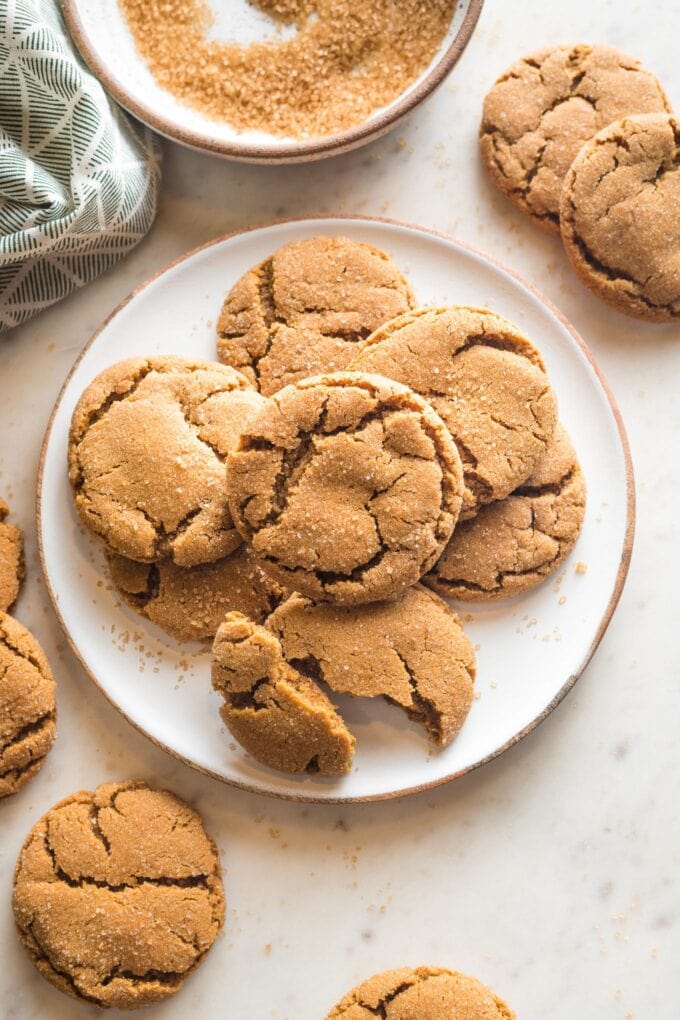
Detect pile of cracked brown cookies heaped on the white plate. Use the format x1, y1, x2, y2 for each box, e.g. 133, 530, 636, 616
69, 237, 585, 775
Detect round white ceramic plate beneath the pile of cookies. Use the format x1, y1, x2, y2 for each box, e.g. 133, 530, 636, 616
38, 218, 633, 801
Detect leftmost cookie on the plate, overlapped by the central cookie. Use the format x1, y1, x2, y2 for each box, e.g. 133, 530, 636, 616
68, 356, 263, 567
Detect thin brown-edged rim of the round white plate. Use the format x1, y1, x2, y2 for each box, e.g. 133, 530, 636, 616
36, 213, 636, 804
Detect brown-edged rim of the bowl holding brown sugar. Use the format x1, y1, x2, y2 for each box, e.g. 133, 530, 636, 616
61, 0, 484, 163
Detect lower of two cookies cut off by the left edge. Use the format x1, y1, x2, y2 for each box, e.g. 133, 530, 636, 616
0, 612, 56, 799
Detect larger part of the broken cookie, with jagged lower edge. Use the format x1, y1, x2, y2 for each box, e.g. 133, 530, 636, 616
266, 584, 475, 747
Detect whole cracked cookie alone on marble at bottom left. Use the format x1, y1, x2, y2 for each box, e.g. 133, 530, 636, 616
12, 781, 224, 1009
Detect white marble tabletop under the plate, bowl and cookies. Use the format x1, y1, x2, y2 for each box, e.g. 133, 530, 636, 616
0, 0, 680, 1020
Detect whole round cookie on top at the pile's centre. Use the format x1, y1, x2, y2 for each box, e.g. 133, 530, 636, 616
227, 372, 463, 603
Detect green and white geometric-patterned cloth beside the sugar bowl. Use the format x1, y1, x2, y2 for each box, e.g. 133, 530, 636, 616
0, 0, 160, 333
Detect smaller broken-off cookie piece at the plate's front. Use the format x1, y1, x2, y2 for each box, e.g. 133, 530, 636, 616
212, 613, 355, 775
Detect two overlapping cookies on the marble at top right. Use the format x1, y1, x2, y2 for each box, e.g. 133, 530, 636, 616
480, 45, 680, 322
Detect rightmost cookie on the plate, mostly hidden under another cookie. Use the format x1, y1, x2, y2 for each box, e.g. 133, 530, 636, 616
424, 425, 585, 602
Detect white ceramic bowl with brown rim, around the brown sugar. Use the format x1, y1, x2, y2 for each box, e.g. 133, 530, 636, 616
62, 0, 483, 162
